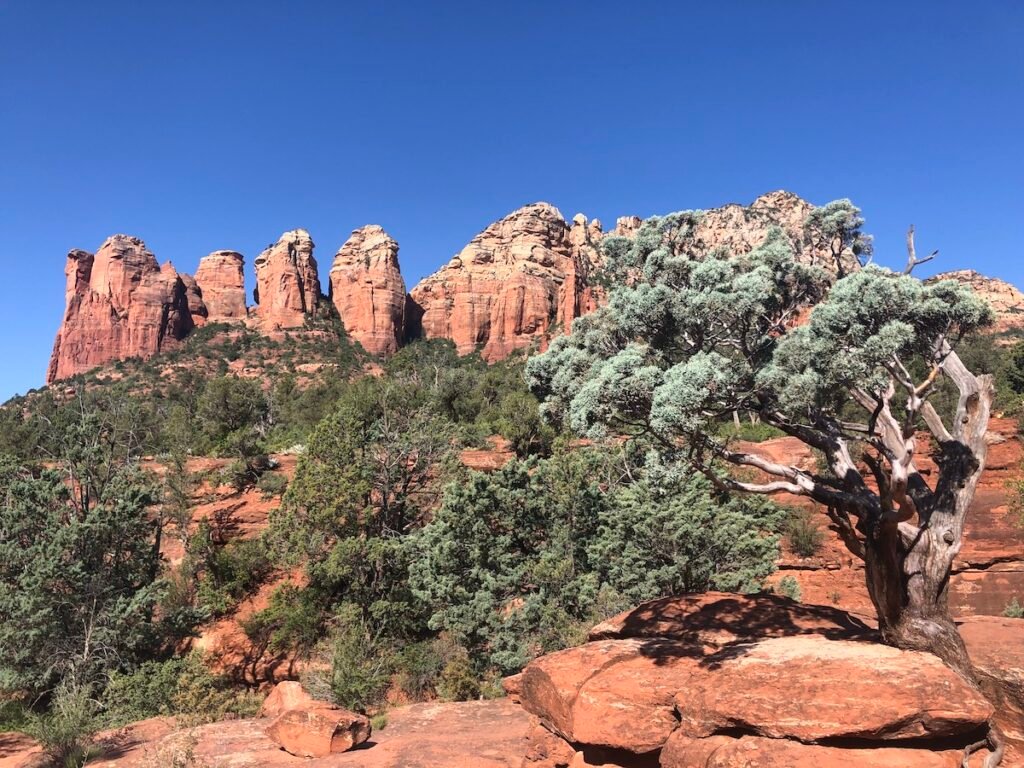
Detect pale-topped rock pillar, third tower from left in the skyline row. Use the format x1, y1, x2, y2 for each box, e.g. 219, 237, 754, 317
255, 229, 321, 329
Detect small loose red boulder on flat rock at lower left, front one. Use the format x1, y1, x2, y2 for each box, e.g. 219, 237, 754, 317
266, 706, 371, 758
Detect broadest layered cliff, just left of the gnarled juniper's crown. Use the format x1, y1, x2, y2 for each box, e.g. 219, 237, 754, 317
411, 203, 601, 360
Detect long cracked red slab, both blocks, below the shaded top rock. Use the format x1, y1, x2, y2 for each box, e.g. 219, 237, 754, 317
520, 634, 992, 754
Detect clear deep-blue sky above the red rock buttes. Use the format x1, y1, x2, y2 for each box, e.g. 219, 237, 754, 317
0, 0, 1024, 399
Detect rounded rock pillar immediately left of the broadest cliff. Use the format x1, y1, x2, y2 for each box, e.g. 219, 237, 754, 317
331, 224, 406, 355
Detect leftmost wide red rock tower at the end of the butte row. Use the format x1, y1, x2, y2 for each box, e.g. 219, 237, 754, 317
46, 234, 203, 383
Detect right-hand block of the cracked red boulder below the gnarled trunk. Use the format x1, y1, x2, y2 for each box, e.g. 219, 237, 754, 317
675, 635, 992, 741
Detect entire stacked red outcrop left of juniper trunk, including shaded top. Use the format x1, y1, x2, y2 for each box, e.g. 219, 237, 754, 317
518, 594, 993, 768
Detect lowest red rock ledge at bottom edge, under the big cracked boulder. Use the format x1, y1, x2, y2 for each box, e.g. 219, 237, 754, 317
660, 732, 981, 768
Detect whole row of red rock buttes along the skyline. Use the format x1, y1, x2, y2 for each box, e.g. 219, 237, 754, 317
47, 191, 1024, 383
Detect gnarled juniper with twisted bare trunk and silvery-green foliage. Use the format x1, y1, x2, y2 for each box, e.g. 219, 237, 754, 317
527, 201, 992, 676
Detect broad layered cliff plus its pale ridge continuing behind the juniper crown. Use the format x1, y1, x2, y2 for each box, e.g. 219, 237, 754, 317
410, 191, 859, 360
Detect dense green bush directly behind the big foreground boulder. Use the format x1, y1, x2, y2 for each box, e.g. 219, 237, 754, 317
411, 451, 779, 680
